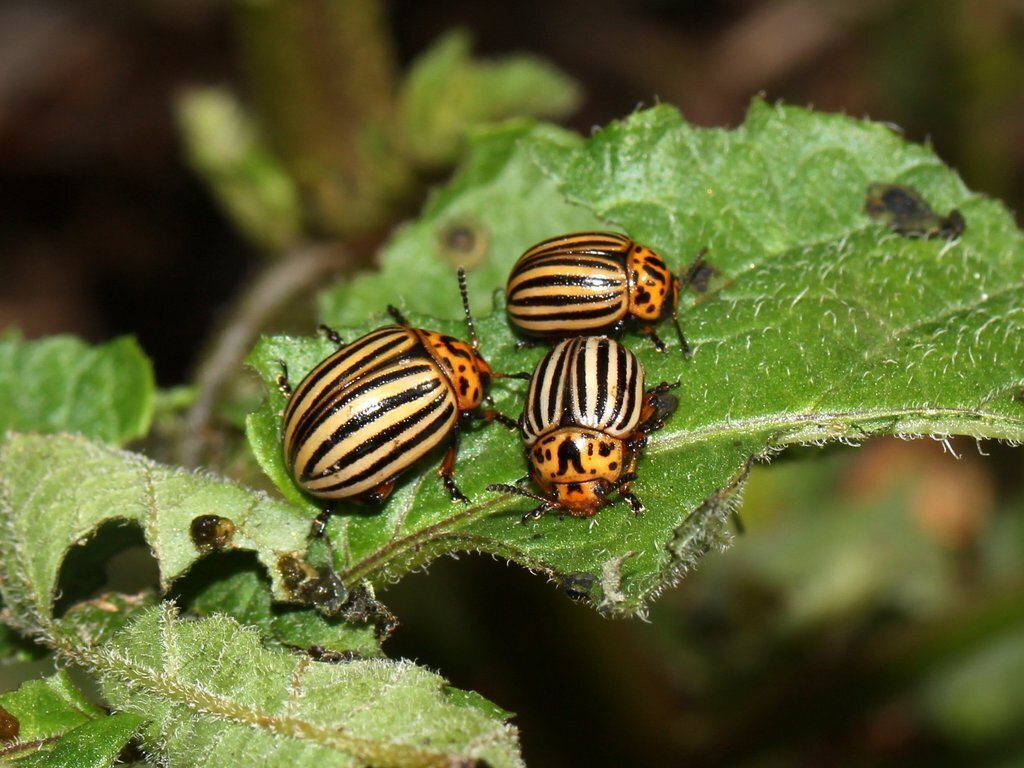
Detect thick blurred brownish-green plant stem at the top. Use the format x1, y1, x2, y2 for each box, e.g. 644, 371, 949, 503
234, 0, 411, 236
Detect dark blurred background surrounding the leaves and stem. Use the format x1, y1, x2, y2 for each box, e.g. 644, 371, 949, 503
0, 0, 1024, 766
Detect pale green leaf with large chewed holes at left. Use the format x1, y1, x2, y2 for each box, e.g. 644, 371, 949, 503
0, 434, 309, 632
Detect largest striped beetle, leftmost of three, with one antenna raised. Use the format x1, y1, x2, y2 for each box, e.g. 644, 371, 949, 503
278, 267, 525, 534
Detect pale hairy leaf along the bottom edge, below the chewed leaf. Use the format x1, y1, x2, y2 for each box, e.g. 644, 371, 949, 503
89, 606, 521, 768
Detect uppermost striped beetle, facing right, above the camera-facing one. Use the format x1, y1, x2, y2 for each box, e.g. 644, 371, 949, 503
505, 232, 700, 356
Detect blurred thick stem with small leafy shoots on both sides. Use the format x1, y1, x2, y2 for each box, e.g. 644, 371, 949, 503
177, 22, 580, 243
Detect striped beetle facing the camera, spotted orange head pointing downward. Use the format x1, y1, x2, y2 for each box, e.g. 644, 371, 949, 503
487, 336, 678, 522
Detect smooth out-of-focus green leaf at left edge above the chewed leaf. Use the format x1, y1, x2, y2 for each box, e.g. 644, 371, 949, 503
0, 332, 155, 443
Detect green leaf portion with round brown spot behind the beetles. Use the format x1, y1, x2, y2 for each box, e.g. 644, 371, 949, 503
319, 122, 600, 325
